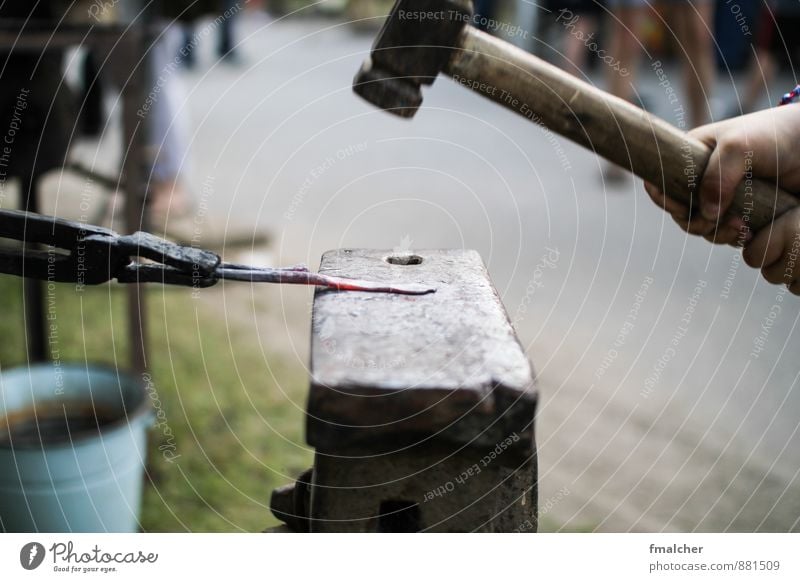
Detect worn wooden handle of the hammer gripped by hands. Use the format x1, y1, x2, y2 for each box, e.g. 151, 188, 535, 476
445, 26, 798, 230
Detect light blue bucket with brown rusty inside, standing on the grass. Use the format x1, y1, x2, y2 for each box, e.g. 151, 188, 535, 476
0, 364, 153, 532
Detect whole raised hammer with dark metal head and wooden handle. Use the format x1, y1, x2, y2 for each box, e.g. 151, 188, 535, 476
353, 0, 798, 230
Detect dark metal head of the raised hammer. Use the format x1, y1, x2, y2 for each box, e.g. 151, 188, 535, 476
353, 0, 472, 117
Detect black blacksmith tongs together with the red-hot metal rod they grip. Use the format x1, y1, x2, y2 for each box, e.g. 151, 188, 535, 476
0, 210, 435, 295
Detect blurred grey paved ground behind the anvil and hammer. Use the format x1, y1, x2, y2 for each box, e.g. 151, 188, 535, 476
177, 13, 800, 531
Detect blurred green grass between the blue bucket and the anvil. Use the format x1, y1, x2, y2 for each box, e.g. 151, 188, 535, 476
0, 277, 312, 532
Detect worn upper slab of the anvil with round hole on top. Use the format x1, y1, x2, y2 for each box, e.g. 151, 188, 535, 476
307, 249, 536, 458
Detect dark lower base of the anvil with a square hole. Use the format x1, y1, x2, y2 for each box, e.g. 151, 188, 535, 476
310, 437, 538, 533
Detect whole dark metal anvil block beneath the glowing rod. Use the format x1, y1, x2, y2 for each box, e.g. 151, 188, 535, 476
272, 249, 537, 532
